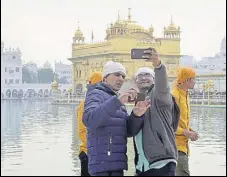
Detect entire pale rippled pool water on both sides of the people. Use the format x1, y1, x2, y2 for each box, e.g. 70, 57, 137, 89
1, 101, 226, 176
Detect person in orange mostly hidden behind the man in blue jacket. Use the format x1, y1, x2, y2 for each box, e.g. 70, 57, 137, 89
76, 72, 102, 176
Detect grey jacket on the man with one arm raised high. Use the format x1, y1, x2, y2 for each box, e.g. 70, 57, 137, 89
134, 64, 180, 165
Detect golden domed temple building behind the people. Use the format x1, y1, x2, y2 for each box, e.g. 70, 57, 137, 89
69, 9, 180, 90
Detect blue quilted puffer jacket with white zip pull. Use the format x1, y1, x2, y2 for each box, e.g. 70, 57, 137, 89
83, 83, 143, 175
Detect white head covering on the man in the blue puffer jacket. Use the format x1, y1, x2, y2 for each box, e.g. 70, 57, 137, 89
102, 61, 126, 78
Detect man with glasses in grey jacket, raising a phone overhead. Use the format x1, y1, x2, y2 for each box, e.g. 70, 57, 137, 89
134, 49, 179, 176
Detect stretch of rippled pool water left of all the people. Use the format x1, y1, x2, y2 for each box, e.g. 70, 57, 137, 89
1, 101, 79, 176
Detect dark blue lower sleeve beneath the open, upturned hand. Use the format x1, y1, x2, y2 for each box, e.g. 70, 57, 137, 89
127, 112, 145, 137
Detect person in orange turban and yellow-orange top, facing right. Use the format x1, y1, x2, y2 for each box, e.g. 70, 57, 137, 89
172, 67, 199, 176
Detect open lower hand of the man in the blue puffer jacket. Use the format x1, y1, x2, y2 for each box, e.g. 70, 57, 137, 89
132, 100, 151, 117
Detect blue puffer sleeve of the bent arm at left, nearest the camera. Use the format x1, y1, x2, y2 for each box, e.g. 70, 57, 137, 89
83, 91, 122, 129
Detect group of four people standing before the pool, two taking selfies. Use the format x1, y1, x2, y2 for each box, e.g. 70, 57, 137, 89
77, 49, 199, 176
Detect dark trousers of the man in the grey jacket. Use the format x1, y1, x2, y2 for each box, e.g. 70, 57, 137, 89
136, 162, 176, 176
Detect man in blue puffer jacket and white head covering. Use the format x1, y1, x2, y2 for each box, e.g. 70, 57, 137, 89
83, 61, 150, 176
